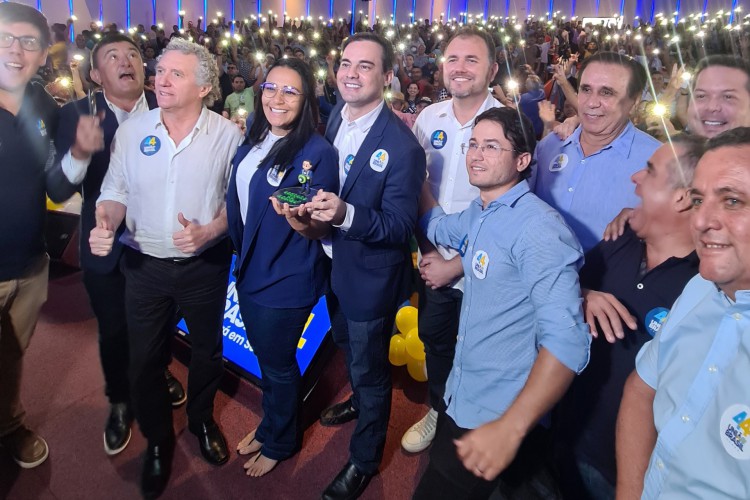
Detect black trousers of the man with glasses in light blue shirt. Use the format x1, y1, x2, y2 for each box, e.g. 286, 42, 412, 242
413, 413, 561, 500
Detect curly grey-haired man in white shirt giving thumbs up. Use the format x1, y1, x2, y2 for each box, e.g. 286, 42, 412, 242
90, 38, 242, 498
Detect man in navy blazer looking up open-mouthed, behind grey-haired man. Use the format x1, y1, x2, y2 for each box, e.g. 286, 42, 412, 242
54, 33, 185, 455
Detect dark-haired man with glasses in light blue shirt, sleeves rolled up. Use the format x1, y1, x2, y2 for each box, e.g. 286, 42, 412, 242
414, 108, 590, 499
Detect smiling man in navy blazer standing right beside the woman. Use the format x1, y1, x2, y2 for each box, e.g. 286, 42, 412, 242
307, 33, 426, 499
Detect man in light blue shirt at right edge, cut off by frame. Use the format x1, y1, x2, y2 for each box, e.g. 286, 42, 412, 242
617, 127, 750, 499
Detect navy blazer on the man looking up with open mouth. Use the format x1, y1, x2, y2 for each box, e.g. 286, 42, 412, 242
53, 91, 157, 274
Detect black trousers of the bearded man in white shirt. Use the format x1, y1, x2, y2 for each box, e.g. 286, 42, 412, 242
418, 279, 464, 412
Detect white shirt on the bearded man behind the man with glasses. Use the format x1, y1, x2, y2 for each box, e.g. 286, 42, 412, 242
412, 92, 502, 291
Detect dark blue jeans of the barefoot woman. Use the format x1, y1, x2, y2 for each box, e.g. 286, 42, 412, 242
238, 296, 312, 460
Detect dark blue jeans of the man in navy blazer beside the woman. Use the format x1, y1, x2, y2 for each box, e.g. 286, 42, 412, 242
326, 293, 396, 474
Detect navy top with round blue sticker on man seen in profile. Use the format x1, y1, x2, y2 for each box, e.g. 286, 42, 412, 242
560, 228, 698, 484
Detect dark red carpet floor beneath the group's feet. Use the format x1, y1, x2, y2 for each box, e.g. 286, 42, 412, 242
0, 273, 427, 500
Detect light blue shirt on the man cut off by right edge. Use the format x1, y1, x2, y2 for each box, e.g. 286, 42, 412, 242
636, 276, 750, 499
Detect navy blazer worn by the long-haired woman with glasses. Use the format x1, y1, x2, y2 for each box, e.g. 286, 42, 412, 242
227, 133, 339, 308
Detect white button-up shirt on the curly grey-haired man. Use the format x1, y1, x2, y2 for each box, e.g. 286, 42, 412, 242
98, 107, 242, 258
